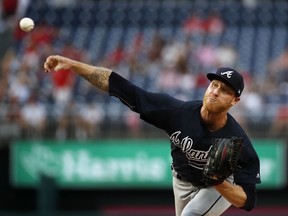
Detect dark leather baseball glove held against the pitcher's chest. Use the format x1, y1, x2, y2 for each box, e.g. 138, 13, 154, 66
203, 137, 243, 186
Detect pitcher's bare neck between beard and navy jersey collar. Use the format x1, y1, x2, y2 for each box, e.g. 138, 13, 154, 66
200, 107, 227, 132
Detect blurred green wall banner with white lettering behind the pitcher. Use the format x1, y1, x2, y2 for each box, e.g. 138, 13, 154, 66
10, 139, 287, 189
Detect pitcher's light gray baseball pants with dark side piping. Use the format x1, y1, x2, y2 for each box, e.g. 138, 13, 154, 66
172, 170, 233, 216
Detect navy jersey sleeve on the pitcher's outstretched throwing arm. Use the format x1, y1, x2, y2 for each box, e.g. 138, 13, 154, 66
109, 72, 181, 130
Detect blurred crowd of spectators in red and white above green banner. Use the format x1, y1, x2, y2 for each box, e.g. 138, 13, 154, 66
0, 1, 288, 140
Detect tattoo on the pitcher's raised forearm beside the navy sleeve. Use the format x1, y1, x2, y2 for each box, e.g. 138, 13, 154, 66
81, 68, 111, 92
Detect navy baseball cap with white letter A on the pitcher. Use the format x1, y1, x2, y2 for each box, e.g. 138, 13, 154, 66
207, 67, 244, 97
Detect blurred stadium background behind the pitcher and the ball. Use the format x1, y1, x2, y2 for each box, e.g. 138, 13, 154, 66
0, 0, 288, 216
